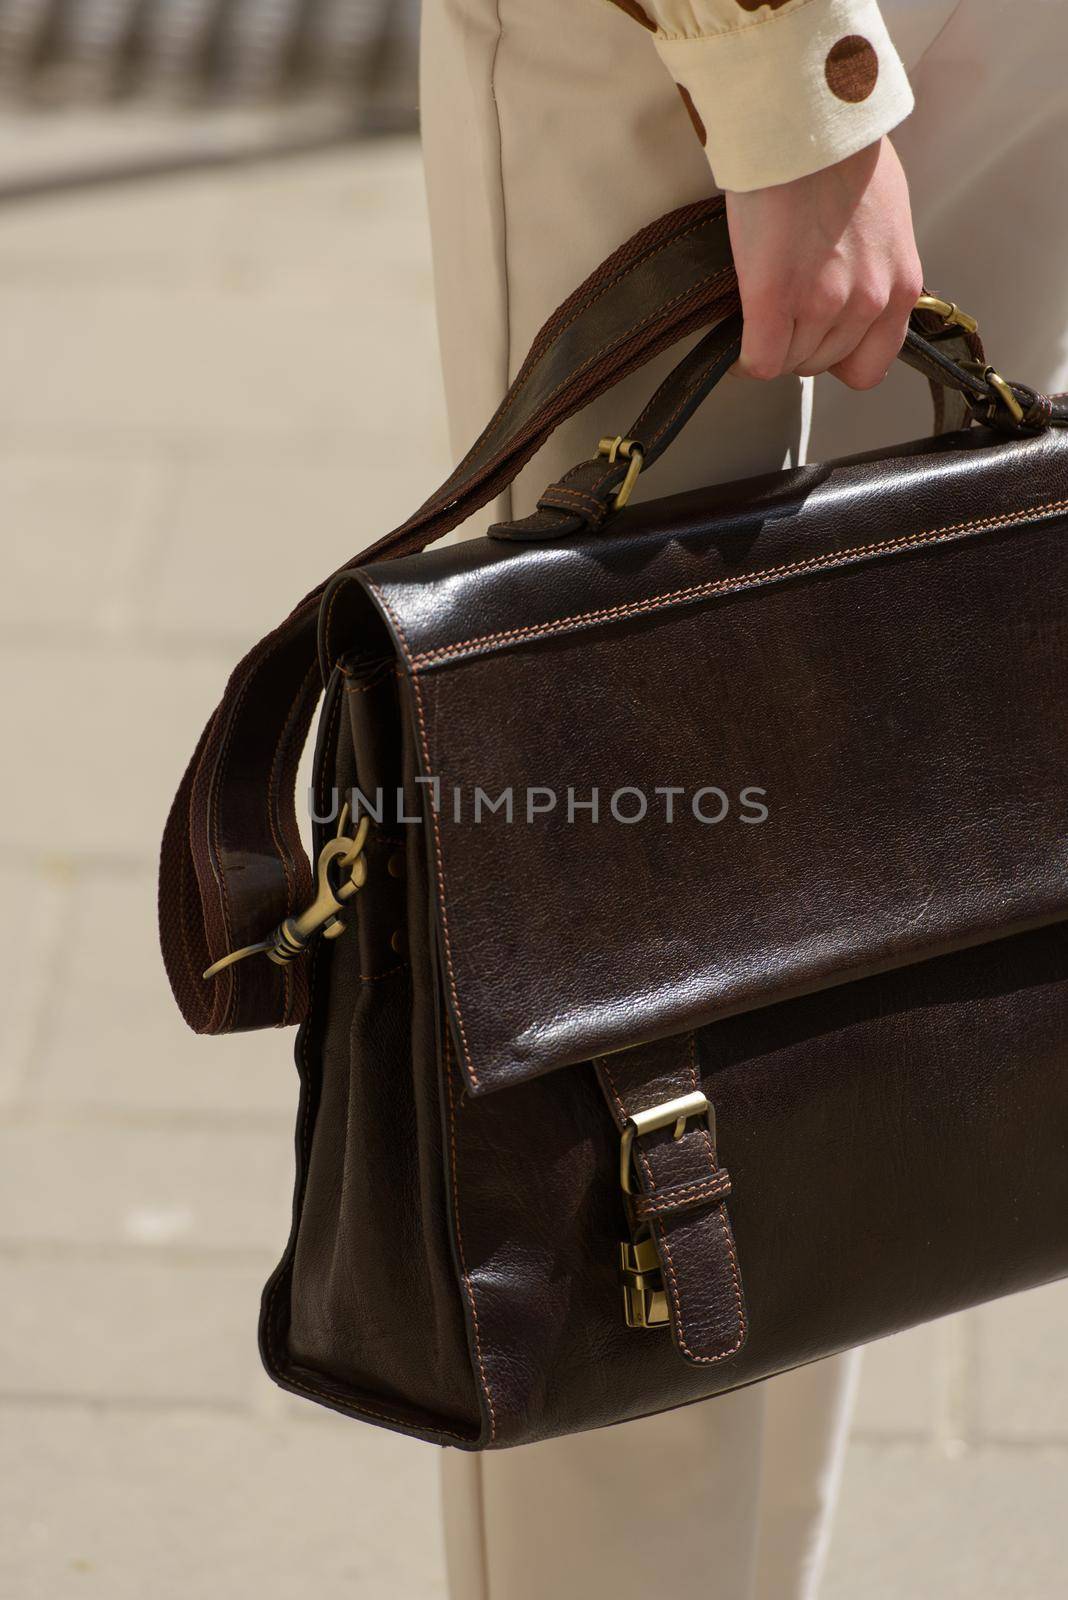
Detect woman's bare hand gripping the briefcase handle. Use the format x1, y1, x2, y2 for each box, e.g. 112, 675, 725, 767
727, 139, 923, 389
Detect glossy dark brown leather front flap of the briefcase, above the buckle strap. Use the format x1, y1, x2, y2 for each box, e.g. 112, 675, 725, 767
361, 432, 1068, 1093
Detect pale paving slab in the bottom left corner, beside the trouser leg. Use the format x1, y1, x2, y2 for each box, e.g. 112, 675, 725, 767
0, 1406, 444, 1600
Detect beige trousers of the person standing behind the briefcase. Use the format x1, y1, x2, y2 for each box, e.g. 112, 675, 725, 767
422, 0, 1068, 1600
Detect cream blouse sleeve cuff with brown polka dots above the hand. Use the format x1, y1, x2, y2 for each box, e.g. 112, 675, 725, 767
614, 0, 913, 190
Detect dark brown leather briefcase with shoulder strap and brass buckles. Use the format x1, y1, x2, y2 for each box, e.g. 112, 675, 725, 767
160, 200, 1068, 1450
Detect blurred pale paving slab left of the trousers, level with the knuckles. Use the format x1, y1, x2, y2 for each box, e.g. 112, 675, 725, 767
0, 280, 435, 443
